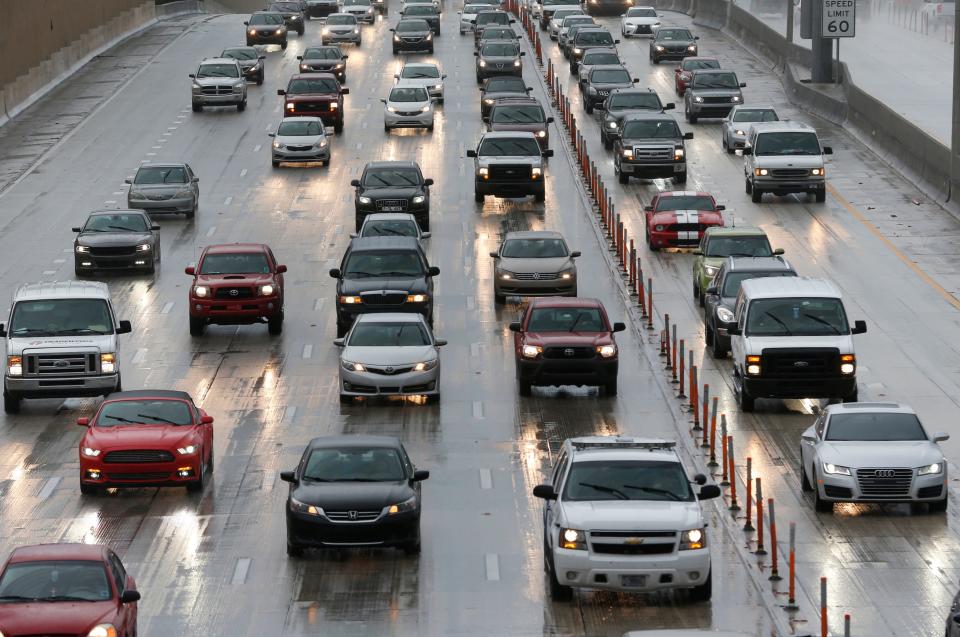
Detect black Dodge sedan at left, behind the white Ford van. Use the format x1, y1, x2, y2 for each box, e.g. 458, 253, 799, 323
73, 210, 160, 277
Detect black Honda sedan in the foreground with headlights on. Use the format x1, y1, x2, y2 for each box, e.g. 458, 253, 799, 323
280, 436, 430, 557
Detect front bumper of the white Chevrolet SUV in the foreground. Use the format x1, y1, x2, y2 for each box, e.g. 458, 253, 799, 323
553, 548, 710, 592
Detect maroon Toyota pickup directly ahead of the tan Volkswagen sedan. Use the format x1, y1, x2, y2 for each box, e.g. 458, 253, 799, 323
510, 297, 626, 396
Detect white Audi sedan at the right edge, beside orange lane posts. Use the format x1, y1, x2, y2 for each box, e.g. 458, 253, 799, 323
800, 403, 950, 512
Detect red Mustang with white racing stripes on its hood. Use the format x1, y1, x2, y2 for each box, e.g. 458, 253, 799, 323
643, 190, 725, 252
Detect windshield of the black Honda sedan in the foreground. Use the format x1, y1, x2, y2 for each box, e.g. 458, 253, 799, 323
300, 447, 407, 482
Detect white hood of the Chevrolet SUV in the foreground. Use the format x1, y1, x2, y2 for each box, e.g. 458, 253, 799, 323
562, 500, 703, 531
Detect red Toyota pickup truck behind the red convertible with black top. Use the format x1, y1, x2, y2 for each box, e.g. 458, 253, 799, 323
185, 243, 287, 336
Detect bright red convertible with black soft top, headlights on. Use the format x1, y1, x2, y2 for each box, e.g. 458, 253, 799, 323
77, 390, 213, 495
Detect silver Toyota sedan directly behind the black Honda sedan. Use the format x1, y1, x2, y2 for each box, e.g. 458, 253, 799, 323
333, 312, 447, 402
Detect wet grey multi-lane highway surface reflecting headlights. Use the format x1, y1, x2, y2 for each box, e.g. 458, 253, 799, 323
0, 6, 960, 636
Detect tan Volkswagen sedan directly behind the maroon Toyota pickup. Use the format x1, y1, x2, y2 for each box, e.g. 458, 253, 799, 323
490, 230, 580, 303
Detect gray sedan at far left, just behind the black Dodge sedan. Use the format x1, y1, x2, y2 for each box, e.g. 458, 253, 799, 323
125, 163, 200, 219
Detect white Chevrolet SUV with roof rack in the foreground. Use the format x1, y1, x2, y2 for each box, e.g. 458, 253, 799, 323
533, 436, 720, 601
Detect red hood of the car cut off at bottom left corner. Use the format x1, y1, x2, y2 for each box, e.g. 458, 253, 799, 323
0, 601, 116, 635
